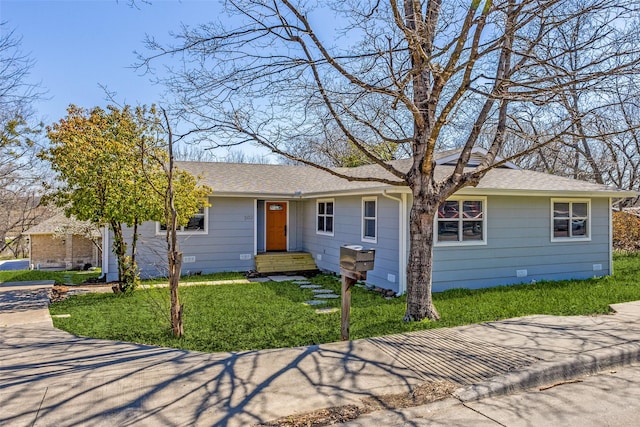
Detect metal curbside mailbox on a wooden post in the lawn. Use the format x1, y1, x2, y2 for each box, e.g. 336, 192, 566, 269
340, 245, 375, 341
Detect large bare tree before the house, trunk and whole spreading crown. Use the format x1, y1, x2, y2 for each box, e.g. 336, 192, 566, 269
141, 0, 640, 321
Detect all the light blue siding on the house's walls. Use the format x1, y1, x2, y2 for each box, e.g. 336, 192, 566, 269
108, 194, 611, 292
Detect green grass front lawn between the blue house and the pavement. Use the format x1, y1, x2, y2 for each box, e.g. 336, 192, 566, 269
50, 255, 640, 352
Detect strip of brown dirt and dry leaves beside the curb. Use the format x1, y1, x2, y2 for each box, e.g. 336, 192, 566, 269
256, 381, 458, 427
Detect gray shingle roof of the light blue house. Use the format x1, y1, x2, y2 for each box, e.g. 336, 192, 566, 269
177, 159, 636, 197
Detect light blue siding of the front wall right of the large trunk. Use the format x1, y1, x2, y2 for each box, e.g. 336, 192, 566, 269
433, 197, 610, 292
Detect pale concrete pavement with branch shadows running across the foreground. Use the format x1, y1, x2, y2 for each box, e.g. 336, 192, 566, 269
0, 284, 640, 426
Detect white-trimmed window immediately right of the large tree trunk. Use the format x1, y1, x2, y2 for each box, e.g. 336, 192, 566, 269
436, 197, 487, 244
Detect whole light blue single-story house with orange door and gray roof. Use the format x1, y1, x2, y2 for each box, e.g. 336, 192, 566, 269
103, 150, 636, 293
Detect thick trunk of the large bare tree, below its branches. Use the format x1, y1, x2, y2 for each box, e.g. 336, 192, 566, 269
403, 185, 440, 322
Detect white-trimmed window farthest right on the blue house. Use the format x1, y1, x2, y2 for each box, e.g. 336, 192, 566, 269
551, 199, 591, 241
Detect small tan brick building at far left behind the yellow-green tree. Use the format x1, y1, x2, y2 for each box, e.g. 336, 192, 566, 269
25, 213, 102, 270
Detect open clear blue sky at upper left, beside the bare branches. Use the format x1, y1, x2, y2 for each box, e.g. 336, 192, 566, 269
0, 0, 264, 155
